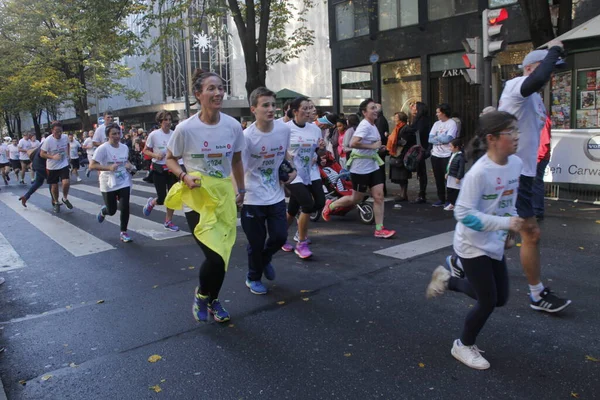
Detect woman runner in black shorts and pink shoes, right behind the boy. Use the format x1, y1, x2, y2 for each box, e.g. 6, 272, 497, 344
282, 97, 325, 258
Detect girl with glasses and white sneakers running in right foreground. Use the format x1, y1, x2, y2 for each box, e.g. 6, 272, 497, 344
426, 111, 524, 369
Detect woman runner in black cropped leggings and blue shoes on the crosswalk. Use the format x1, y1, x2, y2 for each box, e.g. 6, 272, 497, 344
90, 123, 135, 243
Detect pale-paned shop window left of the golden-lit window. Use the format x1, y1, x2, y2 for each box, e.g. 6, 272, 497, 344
340, 65, 373, 114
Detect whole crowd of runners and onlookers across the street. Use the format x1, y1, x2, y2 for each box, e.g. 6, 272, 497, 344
0, 41, 570, 369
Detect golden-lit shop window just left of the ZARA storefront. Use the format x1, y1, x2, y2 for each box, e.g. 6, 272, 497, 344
381, 58, 421, 126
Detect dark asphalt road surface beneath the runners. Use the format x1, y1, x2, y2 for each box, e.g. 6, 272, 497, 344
0, 173, 600, 400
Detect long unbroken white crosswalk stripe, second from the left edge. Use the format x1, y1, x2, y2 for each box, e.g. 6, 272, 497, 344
0, 190, 114, 257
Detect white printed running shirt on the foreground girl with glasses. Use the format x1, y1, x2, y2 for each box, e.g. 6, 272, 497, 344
454, 154, 523, 260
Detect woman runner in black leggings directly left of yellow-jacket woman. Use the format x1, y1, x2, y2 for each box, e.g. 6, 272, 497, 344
144, 111, 179, 232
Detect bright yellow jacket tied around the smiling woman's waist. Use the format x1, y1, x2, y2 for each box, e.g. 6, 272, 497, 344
165, 172, 237, 271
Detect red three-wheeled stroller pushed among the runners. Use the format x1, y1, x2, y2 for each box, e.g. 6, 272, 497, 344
310, 151, 375, 225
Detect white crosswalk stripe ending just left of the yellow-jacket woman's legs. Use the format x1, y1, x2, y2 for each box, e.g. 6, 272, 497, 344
37, 191, 190, 240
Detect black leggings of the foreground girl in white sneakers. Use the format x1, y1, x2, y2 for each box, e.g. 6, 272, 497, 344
448, 256, 508, 346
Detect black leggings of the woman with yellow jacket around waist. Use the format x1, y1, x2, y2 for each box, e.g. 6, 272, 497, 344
185, 211, 225, 301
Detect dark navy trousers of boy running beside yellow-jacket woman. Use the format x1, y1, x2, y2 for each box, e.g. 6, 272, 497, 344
241, 200, 287, 281
